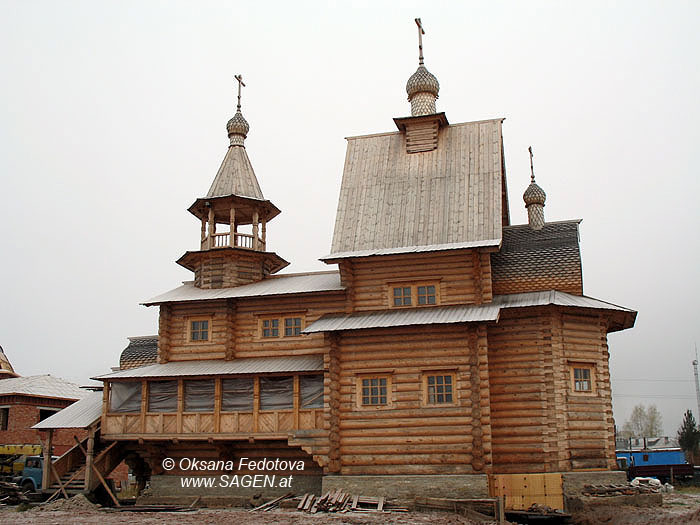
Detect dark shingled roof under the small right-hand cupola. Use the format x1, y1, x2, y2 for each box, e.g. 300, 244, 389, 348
491, 220, 583, 295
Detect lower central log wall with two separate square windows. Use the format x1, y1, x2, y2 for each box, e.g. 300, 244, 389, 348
338, 324, 491, 475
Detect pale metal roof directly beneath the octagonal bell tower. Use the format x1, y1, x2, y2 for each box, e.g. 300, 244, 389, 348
142, 271, 344, 306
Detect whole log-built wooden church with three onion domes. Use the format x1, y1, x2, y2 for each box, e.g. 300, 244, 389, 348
90, 19, 636, 499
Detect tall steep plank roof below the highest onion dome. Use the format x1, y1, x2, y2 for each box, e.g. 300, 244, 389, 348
329, 119, 506, 258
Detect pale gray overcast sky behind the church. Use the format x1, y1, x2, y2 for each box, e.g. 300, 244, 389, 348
0, 0, 700, 435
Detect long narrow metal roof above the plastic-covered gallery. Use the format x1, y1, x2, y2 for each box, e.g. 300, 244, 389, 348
93, 355, 323, 380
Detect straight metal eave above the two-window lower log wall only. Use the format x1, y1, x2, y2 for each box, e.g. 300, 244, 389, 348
303, 305, 499, 334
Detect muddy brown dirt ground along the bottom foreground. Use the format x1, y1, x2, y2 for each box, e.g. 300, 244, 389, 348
0, 491, 700, 525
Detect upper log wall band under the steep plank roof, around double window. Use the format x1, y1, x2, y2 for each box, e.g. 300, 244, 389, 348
340, 249, 493, 311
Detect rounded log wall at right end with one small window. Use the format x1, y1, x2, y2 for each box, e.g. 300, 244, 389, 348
488, 307, 614, 473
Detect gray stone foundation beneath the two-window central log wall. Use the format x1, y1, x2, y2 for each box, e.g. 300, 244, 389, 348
322, 474, 489, 502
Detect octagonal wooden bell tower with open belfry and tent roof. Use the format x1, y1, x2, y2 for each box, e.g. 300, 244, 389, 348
177, 75, 289, 288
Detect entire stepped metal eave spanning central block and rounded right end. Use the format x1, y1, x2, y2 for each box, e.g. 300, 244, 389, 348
303, 290, 637, 334
